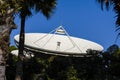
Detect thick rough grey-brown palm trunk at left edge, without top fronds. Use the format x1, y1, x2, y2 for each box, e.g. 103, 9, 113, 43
0, 11, 16, 80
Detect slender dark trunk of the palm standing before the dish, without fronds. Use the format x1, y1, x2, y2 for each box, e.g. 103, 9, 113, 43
15, 17, 25, 80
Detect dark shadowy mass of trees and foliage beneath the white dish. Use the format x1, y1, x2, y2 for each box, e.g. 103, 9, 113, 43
6, 46, 120, 80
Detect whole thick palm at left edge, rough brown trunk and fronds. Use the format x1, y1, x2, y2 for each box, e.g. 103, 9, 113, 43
0, 0, 16, 79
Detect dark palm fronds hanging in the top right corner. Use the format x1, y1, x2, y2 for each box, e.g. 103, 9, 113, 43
97, 0, 120, 36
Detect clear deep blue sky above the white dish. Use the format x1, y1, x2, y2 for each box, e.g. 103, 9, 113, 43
11, 0, 120, 50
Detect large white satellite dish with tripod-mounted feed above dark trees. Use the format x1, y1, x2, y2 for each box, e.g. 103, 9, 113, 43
14, 26, 103, 57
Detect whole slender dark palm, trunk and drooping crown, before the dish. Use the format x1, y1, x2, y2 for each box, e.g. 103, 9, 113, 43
16, 0, 56, 80
